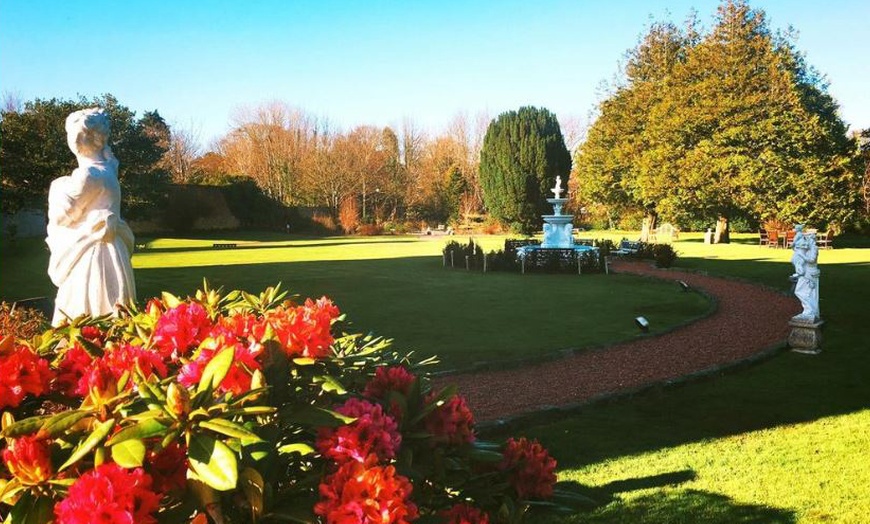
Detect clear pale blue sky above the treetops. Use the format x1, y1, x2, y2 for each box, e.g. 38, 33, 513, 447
0, 0, 870, 144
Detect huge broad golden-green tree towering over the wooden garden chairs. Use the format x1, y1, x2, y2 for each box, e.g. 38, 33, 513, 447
575, 0, 859, 241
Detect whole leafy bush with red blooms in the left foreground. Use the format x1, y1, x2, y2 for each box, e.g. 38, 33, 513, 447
0, 288, 584, 524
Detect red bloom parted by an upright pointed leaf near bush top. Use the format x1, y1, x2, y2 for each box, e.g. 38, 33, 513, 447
178, 333, 261, 395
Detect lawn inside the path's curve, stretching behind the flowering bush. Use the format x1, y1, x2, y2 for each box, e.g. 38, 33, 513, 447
0, 233, 711, 369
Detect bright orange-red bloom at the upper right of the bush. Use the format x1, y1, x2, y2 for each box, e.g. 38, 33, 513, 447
254, 297, 340, 358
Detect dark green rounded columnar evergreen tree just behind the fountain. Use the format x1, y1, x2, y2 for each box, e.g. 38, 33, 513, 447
480, 107, 571, 232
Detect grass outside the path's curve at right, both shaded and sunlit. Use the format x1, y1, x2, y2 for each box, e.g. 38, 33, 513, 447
500, 235, 870, 524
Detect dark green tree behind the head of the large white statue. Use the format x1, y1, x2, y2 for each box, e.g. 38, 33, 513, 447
0, 95, 169, 218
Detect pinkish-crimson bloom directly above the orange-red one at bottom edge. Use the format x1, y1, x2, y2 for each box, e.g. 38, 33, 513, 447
317, 398, 402, 464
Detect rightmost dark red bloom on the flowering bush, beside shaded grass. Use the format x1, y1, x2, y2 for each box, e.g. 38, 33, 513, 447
499, 438, 556, 499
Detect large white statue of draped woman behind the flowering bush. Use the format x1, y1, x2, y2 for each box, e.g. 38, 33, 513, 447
46, 108, 136, 326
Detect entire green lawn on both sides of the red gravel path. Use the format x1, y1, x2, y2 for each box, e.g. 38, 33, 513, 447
8, 229, 870, 524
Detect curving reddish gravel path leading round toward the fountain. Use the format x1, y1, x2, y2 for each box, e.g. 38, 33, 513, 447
436, 261, 800, 421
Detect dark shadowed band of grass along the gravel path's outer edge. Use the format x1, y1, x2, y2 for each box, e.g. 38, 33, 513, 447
508, 259, 870, 468
